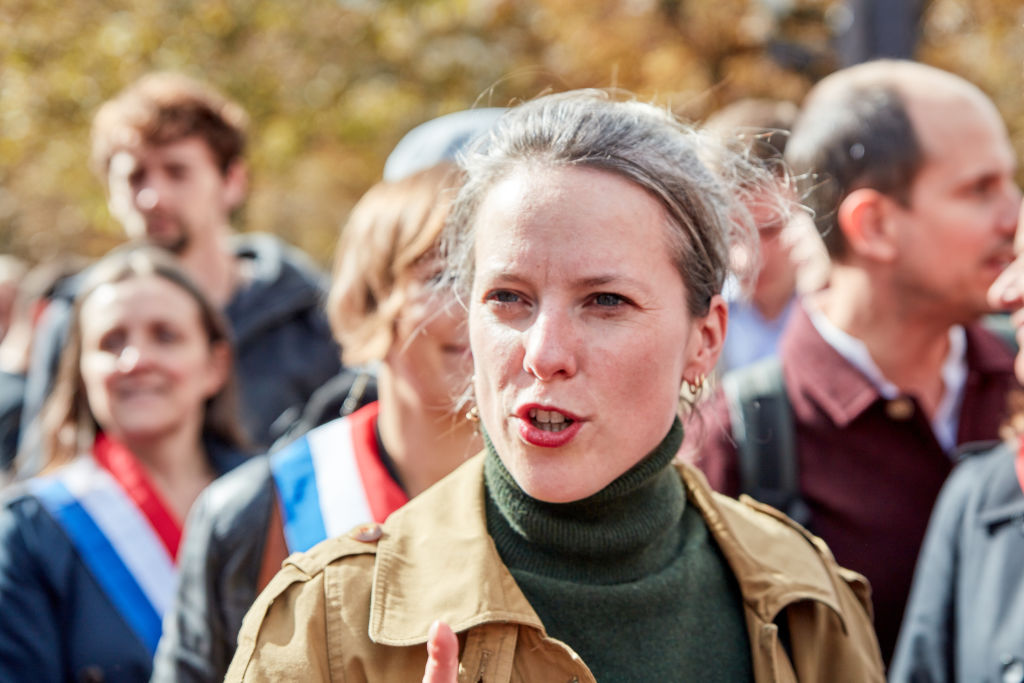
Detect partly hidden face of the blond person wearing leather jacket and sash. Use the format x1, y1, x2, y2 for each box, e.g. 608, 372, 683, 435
385, 256, 473, 413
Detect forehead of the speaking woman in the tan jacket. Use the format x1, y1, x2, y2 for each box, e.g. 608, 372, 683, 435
475, 166, 674, 279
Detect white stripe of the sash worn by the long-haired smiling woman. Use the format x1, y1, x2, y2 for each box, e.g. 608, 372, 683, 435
54, 457, 177, 616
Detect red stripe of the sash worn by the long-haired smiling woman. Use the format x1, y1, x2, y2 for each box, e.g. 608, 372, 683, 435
92, 433, 181, 560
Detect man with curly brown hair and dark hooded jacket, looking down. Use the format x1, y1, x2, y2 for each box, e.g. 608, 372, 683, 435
23, 73, 341, 464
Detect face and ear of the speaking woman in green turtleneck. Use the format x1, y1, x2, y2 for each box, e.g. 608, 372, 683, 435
469, 167, 726, 503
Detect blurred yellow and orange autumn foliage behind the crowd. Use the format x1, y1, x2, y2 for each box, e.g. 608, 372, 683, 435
0, 0, 1024, 264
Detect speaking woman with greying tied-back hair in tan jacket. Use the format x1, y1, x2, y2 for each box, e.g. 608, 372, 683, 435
228, 92, 882, 682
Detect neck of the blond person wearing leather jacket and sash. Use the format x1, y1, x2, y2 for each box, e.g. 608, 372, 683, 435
377, 362, 482, 498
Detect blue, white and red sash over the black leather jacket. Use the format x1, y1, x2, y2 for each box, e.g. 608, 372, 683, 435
270, 402, 409, 553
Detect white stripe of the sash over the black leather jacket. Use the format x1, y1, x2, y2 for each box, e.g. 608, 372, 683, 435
306, 418, 374, 538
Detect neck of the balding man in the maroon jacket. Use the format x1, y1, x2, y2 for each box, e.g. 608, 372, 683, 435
813, 267, 956, 416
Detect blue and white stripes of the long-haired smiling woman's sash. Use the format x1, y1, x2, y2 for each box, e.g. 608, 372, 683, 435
30, 439, 180, 653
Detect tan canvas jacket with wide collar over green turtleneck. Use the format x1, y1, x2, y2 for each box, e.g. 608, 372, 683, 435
225, 456, 884, 683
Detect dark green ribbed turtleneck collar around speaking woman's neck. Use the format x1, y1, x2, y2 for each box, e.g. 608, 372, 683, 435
483, 418, 686, 584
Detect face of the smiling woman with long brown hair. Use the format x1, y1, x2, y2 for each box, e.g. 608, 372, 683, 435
80, 275, 228, 444
